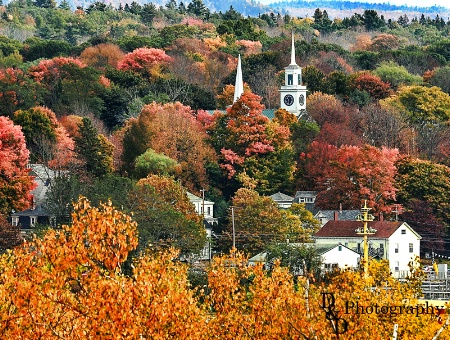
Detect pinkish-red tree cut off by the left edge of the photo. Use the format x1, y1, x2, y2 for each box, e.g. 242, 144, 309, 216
0, 116, 35, 216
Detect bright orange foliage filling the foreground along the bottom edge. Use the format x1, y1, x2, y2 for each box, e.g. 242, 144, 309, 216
0, 198, 450, 340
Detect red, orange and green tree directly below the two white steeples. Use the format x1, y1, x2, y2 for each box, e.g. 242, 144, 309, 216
208, 92, 294, 197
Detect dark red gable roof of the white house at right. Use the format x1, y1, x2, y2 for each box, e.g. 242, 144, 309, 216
314, 220, 421, 239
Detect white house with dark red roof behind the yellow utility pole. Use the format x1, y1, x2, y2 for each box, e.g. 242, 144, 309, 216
314, 220, 421, 278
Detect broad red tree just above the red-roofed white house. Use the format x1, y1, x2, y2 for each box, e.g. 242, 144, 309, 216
302, 142, 398, 211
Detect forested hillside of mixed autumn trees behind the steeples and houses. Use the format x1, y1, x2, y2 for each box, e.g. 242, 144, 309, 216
0, 0, 450, 255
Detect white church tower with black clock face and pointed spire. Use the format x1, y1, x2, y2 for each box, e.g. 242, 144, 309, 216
279, 32, 307, 117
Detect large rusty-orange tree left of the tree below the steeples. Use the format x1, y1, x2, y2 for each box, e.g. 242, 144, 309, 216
123, 102, 215, 192
